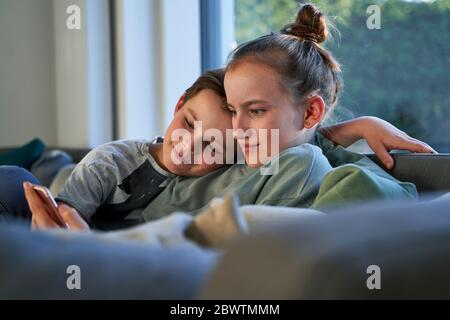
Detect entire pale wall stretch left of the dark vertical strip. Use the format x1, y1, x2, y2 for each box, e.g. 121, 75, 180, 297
0, 0, 112, 147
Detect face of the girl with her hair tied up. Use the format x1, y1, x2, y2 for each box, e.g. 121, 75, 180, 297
225, 60, 303, 167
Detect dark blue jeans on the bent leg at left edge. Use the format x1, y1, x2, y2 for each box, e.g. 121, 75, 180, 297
0, 166, 40, 222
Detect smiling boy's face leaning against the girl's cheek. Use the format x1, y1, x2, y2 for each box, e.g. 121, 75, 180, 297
163, 89, 231, 176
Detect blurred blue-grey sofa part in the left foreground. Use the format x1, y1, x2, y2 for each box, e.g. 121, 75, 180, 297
0, 224, 217, 299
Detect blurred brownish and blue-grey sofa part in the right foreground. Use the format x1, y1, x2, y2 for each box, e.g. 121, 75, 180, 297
199, 197, 450, 299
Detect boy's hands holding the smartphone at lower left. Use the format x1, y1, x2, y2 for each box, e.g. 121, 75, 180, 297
23, 182, 89, 231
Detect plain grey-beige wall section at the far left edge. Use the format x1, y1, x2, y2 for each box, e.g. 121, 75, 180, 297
0, 0, 57, 146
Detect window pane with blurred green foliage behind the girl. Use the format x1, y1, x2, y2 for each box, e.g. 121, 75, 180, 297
235, 0, 450, 152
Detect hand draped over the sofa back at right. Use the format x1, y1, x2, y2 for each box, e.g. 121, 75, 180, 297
361, 117, 437, 169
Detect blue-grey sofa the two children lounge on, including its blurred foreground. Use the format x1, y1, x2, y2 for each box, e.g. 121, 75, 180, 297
0, 145, 450, 299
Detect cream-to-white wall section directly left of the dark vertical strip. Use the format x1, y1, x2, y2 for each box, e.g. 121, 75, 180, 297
53, 0, 112, 147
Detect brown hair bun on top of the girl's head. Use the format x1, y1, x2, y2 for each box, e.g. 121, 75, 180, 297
281, 4, 328, 44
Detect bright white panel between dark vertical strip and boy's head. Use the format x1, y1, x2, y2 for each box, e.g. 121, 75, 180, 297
114, 0, 201, 139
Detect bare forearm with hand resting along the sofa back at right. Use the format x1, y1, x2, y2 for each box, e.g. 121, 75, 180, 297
319, 117, 436, 169
